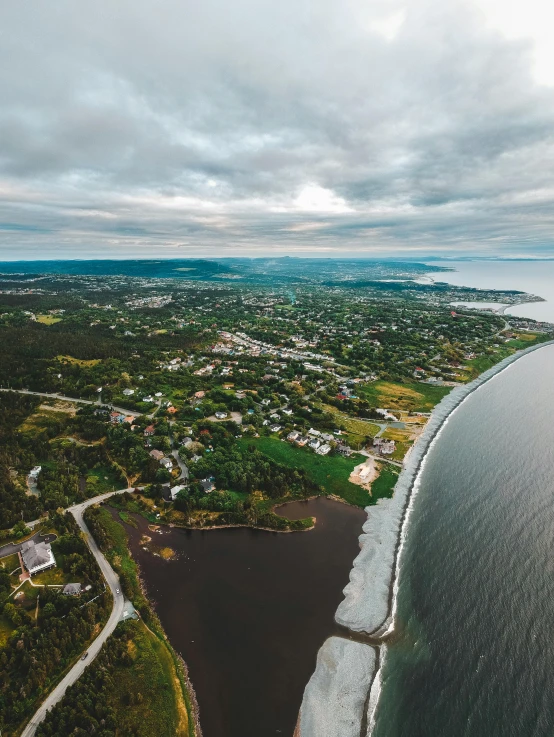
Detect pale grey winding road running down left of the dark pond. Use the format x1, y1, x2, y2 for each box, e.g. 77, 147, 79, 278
21, 489, 134, 737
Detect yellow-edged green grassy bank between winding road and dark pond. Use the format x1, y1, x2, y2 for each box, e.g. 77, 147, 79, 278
110, 621, 190, 737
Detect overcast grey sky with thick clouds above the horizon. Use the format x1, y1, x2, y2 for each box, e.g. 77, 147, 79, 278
0, 0, 554, 259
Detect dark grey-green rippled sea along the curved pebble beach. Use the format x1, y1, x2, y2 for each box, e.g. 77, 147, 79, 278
373, 346, 554, 737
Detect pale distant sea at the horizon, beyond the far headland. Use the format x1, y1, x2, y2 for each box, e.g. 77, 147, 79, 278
428, 261, 554, 323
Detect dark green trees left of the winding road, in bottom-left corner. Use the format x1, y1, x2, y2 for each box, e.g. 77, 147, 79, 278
0, 514, 110, 735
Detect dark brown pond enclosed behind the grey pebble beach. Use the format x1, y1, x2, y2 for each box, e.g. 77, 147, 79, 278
115, 497, 366, 737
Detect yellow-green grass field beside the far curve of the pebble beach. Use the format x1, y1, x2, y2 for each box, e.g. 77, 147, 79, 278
358, 381, 450, 412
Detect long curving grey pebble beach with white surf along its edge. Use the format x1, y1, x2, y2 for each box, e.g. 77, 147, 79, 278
297, 340, 554, 737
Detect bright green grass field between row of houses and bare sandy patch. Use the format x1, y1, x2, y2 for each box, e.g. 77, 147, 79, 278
239, 437, 372, 507
